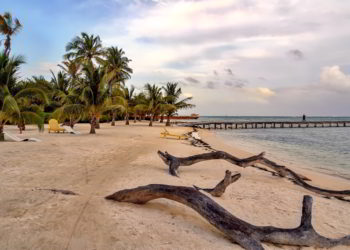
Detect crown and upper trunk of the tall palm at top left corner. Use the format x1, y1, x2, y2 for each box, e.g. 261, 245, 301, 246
0, 12, 22, 56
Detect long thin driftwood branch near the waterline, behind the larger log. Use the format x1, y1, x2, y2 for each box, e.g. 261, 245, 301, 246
158, 151, 350, 198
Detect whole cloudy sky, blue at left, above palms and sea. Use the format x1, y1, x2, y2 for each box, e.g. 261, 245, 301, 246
0, 0, 350, 116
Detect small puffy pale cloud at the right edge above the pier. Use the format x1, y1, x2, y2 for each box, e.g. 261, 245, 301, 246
320, 65, 350, 92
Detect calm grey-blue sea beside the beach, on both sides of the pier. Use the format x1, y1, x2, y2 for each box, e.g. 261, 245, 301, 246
197, 116, 350, 179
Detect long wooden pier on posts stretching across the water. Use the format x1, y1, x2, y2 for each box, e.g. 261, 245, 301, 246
181, 121, 350, 129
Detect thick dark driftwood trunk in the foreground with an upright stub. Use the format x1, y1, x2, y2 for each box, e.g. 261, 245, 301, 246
105, 184, 350, 250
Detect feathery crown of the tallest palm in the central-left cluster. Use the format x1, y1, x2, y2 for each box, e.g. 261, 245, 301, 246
64, 32, 104, 65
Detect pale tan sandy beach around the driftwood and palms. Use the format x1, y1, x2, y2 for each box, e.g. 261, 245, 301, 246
0, 122, 350, 249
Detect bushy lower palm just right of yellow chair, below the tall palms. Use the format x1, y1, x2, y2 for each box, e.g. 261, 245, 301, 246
80, 63, 123, 134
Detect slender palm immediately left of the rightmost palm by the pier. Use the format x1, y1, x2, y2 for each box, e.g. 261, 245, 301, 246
145, 83, 164, 127
